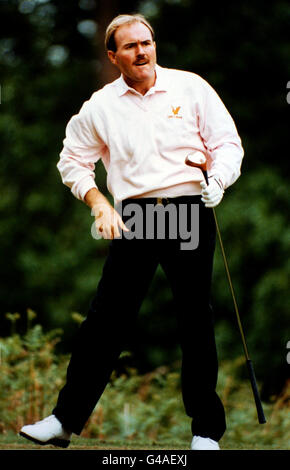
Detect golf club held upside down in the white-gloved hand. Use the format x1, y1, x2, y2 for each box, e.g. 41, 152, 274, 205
185, 151, 266, 424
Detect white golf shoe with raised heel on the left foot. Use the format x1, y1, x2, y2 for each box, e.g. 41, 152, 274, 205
19, 415, 72, 448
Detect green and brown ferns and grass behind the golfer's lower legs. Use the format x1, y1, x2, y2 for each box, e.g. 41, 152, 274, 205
0, 316, 290, 450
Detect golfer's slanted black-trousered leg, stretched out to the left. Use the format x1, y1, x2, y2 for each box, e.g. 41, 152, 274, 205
53, 239, 157, 434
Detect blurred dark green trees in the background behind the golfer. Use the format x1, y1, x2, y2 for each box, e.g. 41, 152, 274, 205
0, 0, 290, 408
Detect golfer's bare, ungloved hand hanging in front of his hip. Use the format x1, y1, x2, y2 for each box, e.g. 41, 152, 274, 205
85, 188, 129, 240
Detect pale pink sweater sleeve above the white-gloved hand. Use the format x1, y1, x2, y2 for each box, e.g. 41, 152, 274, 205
199, 80, 244, 189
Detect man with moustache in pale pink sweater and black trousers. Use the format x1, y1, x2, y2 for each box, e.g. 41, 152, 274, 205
20, 15, 243, 450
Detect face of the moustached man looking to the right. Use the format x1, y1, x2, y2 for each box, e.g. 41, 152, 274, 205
108, 22, 156, 86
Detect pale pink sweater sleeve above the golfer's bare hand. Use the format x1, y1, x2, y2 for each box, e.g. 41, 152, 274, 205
57, 101, 106, 200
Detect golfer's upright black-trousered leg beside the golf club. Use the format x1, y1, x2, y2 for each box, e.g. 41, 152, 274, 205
161, 198, 226, 441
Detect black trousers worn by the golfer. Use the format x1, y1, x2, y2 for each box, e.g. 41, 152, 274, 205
53, 196, 226, 441
